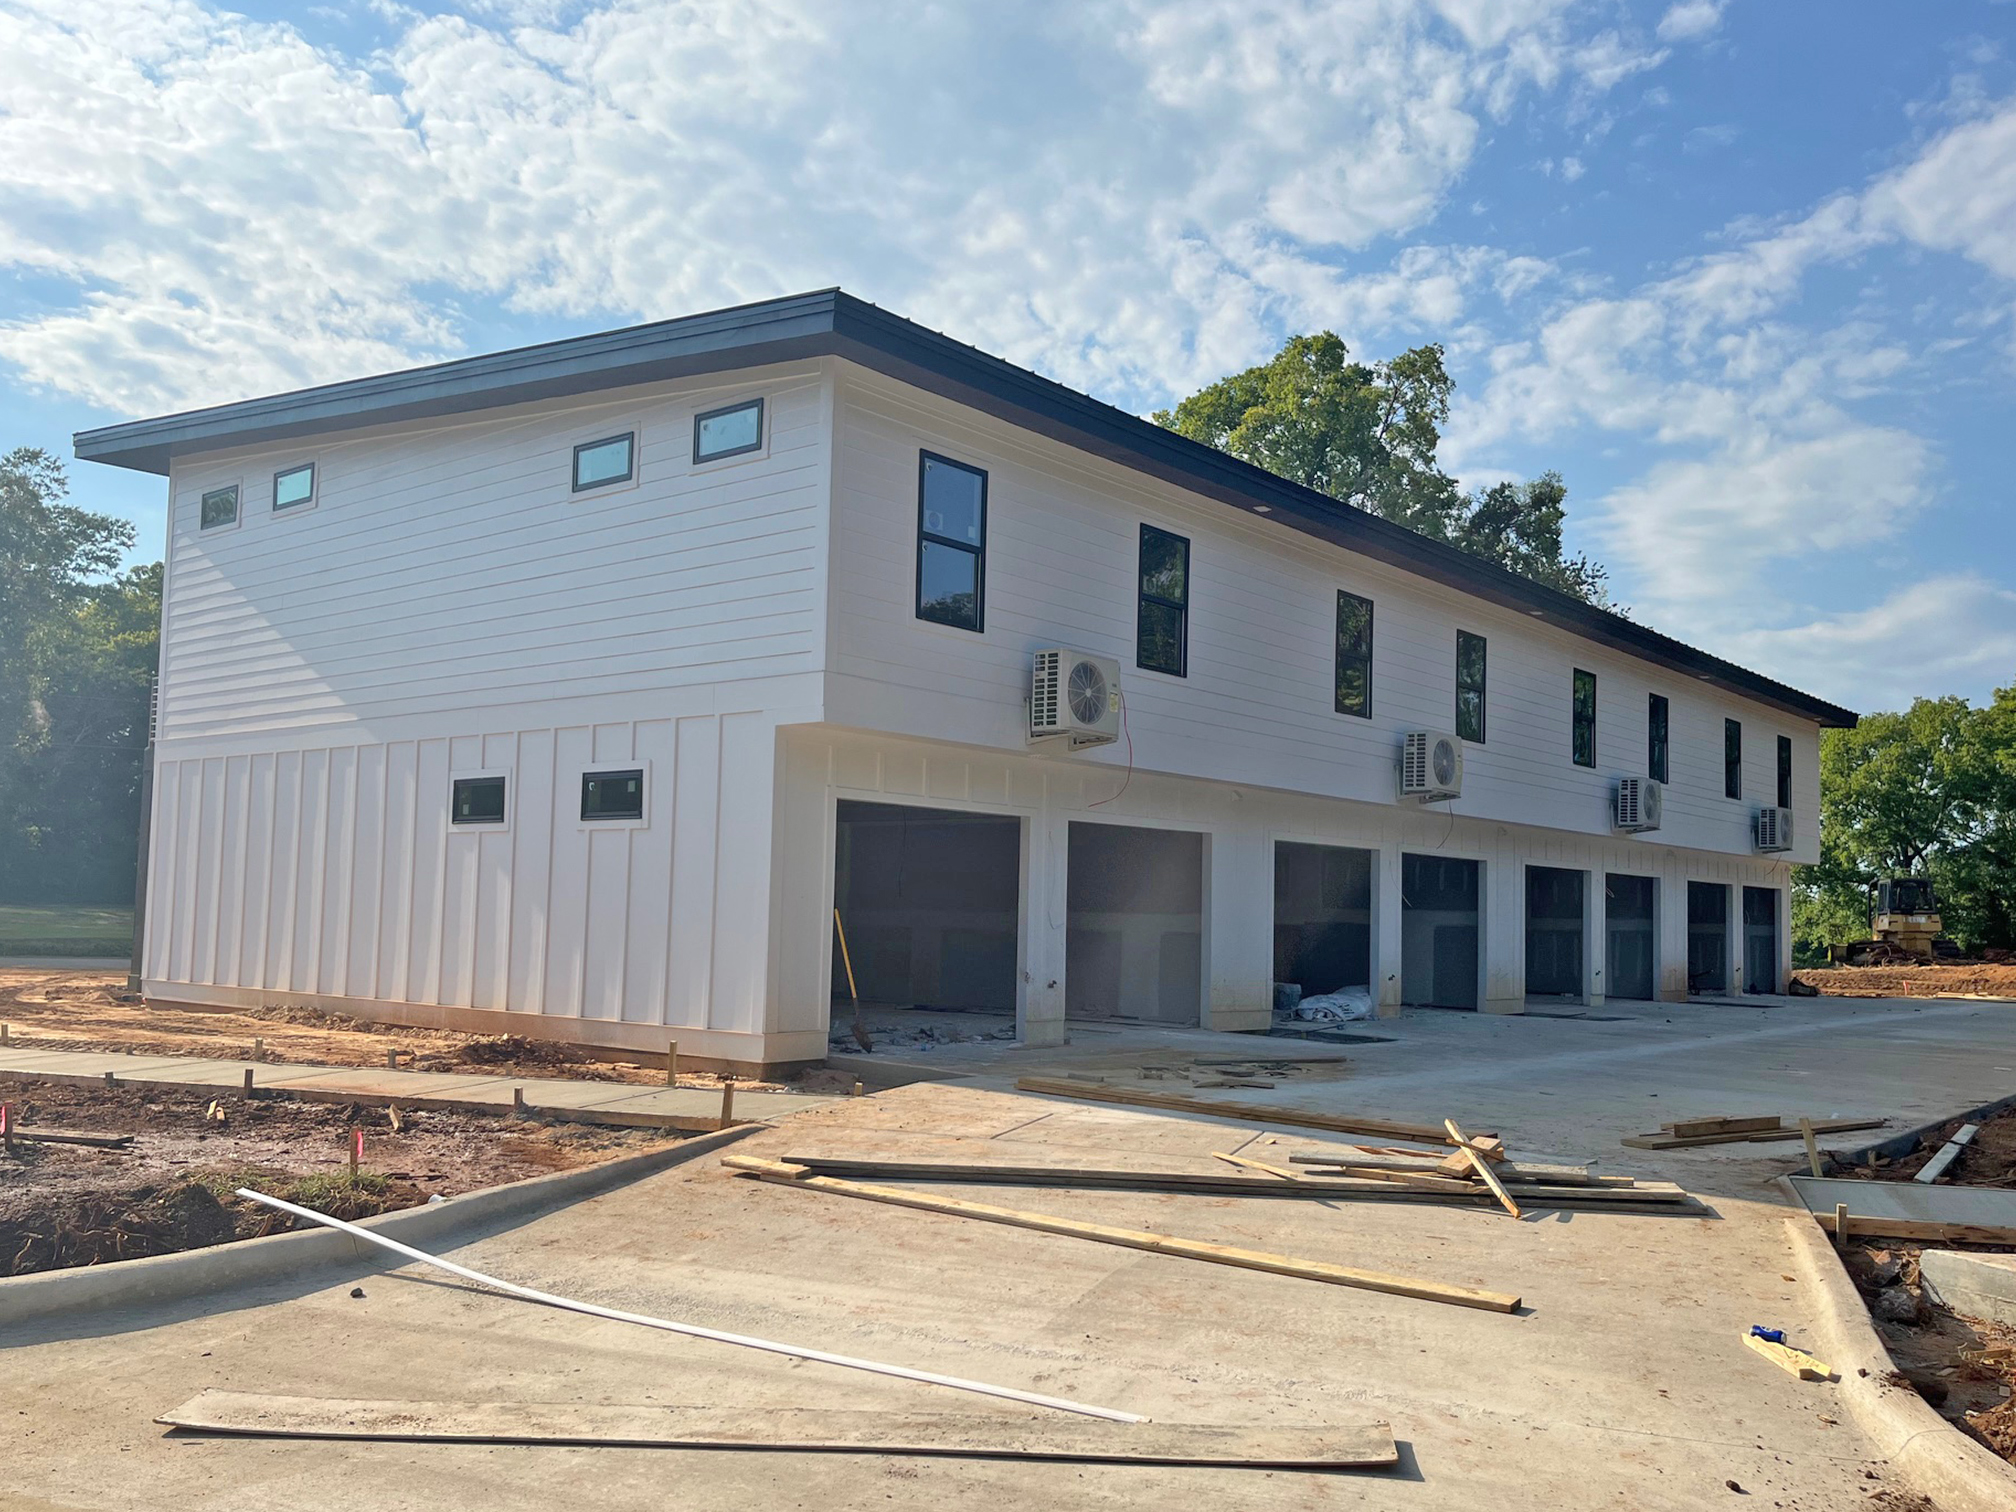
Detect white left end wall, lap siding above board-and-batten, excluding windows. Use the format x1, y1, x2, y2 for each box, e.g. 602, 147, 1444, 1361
145, 363, 831, 1054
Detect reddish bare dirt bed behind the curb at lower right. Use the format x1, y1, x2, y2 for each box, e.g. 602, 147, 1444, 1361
1841, 1111, 2016, 1464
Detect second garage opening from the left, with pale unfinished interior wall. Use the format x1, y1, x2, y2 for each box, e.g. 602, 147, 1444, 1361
1064, 825, 1204, 1024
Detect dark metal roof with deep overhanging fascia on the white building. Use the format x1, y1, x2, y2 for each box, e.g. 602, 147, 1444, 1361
75, 288, 1857, 728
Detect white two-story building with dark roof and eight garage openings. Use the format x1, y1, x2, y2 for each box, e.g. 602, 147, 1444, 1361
77, 290, 1855, 1066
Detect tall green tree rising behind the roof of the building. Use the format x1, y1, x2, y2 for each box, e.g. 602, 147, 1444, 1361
1153, 331, 1617, 609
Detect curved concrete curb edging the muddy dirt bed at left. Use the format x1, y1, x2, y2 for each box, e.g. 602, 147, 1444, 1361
0, 1123, 768, 1329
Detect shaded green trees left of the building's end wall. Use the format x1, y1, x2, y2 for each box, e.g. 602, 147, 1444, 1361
0, 448, 161, 903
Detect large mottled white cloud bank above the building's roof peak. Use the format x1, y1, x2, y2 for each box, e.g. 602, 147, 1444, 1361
0, 0, 1649, 411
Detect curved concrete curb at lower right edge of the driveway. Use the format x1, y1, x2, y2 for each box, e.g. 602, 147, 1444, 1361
1786, 1208, 2016, 1512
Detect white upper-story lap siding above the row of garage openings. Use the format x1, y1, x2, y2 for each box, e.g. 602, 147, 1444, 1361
827, 367, 1818, 859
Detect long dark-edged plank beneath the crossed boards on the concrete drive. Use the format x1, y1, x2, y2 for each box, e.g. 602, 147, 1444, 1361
753, 1153, 1691, 1208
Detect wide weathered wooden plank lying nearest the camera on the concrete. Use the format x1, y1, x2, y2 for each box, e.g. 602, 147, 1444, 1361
155, 1391, 1399, 1470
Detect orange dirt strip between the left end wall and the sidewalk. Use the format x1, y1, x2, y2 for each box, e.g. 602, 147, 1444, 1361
0, 966, 778, 1091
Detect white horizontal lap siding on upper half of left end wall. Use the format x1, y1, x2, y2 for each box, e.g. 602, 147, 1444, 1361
161, 367, 829, 745
